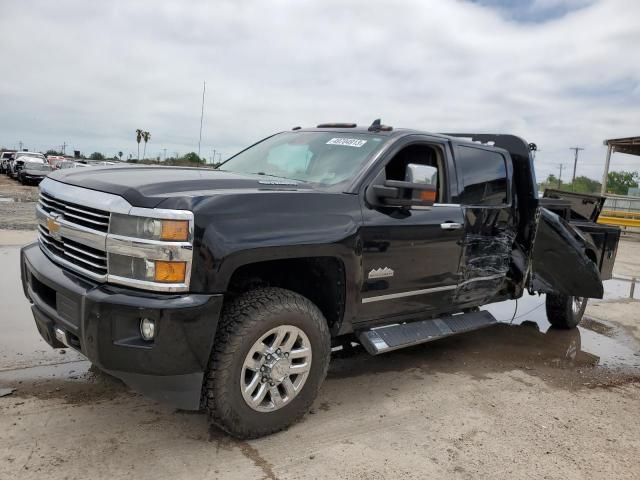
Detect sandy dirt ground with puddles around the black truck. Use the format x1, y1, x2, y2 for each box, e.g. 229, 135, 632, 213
0, 176, 640, 480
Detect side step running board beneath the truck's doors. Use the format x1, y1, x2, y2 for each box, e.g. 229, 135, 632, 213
358, 311, 497, 355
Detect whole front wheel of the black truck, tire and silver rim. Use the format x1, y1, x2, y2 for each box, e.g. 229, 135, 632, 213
203, 288, 331, 438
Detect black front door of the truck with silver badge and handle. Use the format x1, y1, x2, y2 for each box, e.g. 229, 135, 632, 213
358, 142, 464, 322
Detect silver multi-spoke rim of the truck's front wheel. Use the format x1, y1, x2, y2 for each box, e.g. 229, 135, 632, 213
240, 325, 311, 412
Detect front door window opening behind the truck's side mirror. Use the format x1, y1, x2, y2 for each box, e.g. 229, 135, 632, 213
385, 144, 444, 202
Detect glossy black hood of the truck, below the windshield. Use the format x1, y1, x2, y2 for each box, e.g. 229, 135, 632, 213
48, 166, 311, 208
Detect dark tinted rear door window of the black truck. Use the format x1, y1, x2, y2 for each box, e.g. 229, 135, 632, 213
456, 145, 508, 205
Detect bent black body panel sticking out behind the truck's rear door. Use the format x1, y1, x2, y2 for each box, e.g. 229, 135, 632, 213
532, 208, 604, 298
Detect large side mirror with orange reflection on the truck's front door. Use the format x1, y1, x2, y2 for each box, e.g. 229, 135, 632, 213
372, 163, 438, 207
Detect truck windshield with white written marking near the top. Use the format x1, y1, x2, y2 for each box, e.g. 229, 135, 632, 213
220, 132, 384, 186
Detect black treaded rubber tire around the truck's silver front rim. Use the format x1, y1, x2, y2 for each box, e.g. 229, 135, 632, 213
203, 287, 331, 439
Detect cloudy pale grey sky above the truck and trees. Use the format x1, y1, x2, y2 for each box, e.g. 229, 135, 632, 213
0, 0, 640, 180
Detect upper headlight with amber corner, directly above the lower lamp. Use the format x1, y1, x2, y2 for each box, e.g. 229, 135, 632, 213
110, 213, 189, 242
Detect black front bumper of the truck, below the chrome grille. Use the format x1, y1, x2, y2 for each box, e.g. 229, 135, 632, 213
20, 243, 223, 410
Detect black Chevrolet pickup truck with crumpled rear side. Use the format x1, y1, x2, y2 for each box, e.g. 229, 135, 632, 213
21, 121, 619, 438
